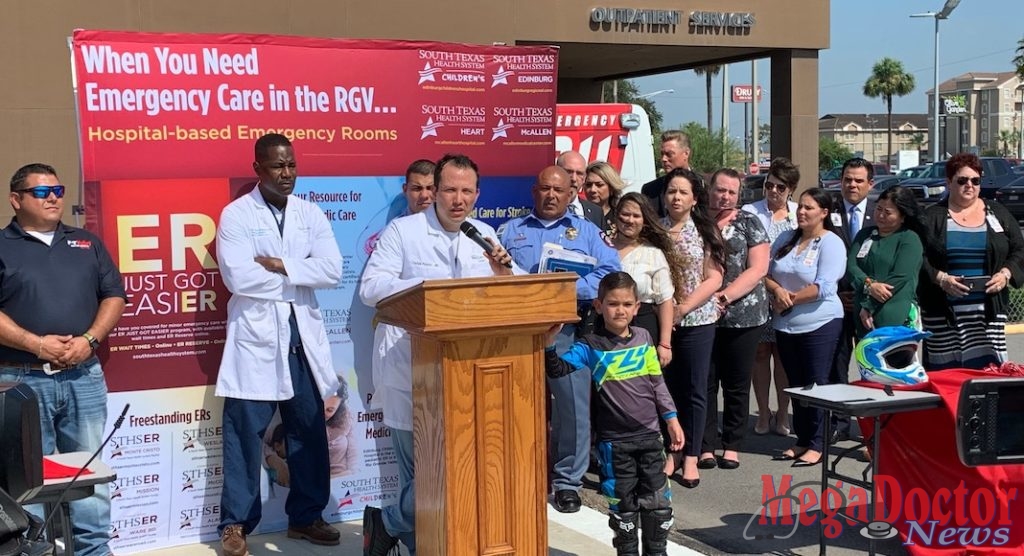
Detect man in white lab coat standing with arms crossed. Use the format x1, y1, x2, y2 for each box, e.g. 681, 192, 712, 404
216, 133, 342, 556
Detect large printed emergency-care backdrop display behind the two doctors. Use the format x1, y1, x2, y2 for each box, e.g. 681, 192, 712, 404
72, 31, 557, 553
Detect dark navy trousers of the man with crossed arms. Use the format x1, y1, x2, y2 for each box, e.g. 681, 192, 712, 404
218, 315, 331, 534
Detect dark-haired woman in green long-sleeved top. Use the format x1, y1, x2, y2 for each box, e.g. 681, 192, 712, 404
847, 185, 926, 339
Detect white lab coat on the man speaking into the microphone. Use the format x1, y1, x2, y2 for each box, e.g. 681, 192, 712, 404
359, 207, 526, 430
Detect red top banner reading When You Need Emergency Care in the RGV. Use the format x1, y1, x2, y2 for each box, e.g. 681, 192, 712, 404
73, 31, 557, 179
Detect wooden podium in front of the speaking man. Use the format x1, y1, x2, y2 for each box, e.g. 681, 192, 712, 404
377, 273, 578, 556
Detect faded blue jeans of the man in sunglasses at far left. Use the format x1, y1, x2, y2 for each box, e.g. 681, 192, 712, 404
0, 357, 111, 556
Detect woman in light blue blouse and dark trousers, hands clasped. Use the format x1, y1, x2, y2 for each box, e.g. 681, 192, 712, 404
765, 187, 846, 467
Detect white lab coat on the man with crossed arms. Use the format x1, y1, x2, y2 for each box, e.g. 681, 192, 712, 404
216, 186, 342, 400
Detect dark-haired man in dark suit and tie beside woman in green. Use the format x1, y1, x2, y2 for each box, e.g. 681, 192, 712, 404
829, 158, 874, 442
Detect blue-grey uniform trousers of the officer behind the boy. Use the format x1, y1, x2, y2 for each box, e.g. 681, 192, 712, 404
548, 326, 591, 491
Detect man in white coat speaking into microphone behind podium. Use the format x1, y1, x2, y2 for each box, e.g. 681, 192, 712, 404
359, 155, 525, 556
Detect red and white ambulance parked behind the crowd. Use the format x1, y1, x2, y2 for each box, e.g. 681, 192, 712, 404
555, 103, 657, 191
